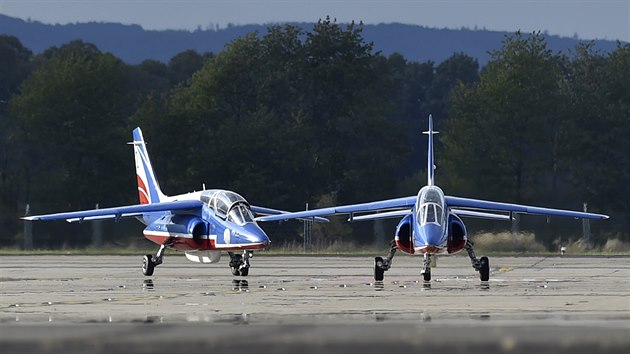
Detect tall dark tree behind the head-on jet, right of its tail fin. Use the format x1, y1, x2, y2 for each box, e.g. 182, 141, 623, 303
442, 33, 566, 203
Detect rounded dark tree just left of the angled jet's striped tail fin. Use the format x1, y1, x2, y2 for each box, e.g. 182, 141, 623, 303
10, 41, 133, 212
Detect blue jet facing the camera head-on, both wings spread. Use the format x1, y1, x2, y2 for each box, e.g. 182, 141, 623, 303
256, 116, 608, 281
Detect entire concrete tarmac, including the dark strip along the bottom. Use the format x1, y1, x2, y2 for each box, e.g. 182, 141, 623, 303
0, 254, 630, 354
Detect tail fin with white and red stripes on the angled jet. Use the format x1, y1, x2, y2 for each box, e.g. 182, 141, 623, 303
129, 128, 166, 204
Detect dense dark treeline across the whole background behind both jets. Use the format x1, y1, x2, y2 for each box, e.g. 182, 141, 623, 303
0, 19, 630, 247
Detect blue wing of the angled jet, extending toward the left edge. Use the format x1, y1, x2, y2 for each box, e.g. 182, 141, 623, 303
22, 200, 203, 222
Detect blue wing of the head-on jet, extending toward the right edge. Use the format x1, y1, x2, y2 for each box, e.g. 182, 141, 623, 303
445, 196, 608, 219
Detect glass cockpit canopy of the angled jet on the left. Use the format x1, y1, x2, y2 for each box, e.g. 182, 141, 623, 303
201, 189, 254, 225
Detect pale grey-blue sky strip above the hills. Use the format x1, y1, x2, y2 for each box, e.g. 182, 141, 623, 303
0, 0, 630, 42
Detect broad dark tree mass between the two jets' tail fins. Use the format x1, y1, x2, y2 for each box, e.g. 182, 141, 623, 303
155, 19, 405, 243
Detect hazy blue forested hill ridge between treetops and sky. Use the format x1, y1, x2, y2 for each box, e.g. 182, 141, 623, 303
0, 15, 616, 66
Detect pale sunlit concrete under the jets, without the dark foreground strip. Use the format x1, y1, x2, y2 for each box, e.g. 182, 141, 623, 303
0, 256, 630, 349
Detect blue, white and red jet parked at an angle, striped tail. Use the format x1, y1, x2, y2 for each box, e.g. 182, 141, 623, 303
23, 128, 328, 276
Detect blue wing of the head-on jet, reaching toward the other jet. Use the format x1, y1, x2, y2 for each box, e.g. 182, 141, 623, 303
252, 196, 416, 221
